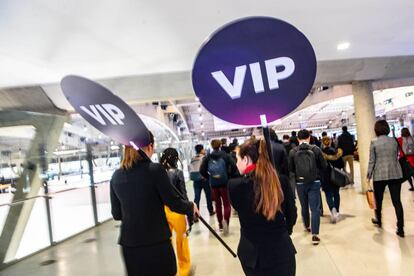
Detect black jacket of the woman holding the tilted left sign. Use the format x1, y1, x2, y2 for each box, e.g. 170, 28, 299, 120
110, 161, 193, 247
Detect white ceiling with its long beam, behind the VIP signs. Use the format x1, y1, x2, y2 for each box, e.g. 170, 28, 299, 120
0, 0, 414, 139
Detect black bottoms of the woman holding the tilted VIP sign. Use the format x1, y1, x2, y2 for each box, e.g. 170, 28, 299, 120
122, 240, 177, 276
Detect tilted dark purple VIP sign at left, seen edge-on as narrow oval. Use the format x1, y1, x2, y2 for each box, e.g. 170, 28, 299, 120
61, 76, 150, 148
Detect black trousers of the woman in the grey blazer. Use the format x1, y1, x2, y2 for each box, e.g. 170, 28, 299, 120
374, 179, 404, 230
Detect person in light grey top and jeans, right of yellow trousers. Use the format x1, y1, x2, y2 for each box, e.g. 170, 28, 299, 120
190, 145, 216, 217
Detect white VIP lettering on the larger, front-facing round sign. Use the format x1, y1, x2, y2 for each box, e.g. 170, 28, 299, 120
211, 57, 295, 100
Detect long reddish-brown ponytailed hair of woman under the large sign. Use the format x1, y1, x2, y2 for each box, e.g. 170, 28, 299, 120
238, 139, 283, 220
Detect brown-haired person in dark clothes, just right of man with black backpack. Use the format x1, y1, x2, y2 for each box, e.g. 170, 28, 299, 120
322, 136, 345, 223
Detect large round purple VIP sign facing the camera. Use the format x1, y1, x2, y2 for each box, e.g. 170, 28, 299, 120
192, 17, 316, 125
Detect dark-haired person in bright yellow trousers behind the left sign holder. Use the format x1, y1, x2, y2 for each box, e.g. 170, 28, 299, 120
160, 148, 192, 276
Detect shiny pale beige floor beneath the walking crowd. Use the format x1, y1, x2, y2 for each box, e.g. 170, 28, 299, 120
0, 163, 414, 276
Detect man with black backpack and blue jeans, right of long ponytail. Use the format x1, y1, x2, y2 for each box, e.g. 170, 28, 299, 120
289, 129, 327, 245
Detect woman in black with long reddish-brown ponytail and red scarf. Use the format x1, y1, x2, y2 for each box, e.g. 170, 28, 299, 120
229, 139, 297, 276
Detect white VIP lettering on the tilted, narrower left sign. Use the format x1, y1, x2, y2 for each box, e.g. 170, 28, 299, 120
80, 104, 125, 126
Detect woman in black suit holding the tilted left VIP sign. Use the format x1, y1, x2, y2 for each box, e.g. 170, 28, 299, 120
110, 134, 198, 276
